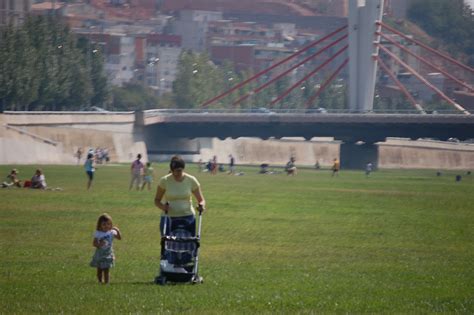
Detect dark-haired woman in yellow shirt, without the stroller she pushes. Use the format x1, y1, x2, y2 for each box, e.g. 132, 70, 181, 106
155, 156, 205, 236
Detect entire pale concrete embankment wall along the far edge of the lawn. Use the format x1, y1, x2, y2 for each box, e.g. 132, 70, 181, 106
0, 112, 474, 170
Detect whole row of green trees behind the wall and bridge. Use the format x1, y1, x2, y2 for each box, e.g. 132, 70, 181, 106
0, 16, 440, 110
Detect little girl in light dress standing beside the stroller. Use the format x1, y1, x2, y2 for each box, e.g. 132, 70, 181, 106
90, 213, 122, 284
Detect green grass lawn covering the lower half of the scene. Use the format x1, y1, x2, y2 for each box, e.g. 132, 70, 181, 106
0, 164, 474, 314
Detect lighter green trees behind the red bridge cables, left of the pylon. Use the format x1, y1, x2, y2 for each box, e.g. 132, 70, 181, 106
173, 51, 346, 109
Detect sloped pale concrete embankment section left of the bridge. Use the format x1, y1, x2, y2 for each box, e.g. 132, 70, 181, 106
0, 112, 146, 164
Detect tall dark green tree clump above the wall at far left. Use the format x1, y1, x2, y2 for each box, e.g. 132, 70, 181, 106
0, 16, 110, 110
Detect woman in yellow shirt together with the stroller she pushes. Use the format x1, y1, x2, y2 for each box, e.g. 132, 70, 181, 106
155, 156, 205, 285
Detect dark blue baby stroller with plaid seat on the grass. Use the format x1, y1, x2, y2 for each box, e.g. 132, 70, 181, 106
155, 207, 203, 285
